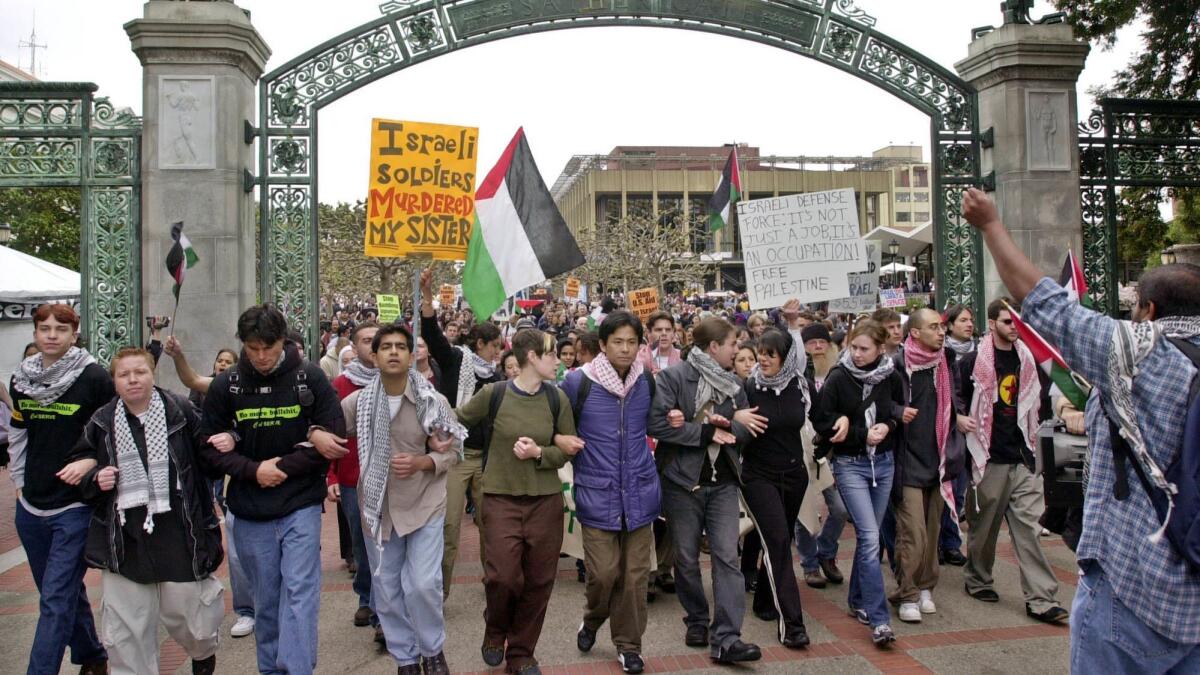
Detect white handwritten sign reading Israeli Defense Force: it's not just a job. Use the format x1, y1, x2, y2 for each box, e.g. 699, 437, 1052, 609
738, 187, 868, 310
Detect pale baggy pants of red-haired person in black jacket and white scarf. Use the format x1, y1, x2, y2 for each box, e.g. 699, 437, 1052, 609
100, 572, 224, 675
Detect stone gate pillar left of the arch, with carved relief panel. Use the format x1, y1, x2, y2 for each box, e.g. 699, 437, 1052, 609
125, 0, 271, 386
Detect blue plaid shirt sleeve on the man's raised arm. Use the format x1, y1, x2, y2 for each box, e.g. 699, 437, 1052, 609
1021, 276, 1117, 389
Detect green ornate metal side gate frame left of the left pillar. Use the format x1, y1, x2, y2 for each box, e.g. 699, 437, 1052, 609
0, 82, 142, 364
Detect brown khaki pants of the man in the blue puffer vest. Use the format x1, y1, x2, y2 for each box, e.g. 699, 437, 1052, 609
582, 525, 654, 653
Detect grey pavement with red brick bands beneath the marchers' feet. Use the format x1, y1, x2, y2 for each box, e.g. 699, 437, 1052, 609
0, 474, 1075, 675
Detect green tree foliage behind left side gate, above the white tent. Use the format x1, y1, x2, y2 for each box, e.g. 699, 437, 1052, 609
0, 187, 80, 271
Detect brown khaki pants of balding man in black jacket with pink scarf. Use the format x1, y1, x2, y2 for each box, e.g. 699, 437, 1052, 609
890, 485, 946, 603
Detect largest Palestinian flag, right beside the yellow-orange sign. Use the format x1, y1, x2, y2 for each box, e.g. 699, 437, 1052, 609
462, 129, 584, 316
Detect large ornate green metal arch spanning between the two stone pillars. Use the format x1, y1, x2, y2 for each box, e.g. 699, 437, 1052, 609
253, 0, 982, 339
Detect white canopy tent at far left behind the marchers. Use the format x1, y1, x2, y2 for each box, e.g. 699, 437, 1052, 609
0, 246, 79, 387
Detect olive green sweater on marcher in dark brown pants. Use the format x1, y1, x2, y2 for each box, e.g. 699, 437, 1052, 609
455, 382, 575, 496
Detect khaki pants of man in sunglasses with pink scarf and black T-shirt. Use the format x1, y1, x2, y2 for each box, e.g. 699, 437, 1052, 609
962, 464, 1058, 613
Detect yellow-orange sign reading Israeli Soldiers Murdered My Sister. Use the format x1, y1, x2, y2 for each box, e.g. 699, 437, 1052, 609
364, 119, 479, 261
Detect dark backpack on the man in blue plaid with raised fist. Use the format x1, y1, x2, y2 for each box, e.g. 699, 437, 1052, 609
1102, 338, 1200, 571
